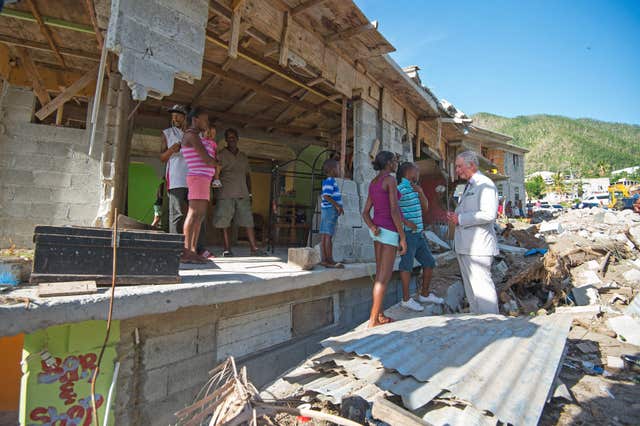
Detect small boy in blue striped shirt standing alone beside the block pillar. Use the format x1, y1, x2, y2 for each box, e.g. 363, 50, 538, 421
320, 159, 344, 268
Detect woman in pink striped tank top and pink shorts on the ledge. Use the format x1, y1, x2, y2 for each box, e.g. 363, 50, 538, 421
180, 107, 218, 263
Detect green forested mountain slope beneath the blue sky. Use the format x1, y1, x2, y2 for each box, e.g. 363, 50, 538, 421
473, 112, 640, 177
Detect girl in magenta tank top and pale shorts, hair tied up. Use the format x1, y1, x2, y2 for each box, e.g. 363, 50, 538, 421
362, 151, 407, 327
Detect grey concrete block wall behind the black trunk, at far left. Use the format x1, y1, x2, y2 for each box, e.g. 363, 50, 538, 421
0, 85, 100, 248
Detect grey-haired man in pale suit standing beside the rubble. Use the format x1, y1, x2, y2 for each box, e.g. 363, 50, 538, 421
448, 151, 498, 314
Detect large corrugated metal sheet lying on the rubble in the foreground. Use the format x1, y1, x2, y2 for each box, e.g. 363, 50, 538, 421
323, 315, 571, 425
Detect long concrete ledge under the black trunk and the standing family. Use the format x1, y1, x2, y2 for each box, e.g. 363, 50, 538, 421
0, 253, 450, 337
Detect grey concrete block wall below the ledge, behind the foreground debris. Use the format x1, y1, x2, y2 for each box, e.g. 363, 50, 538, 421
114, 274, 410, 425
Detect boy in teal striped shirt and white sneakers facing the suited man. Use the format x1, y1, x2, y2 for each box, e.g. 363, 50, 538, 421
396, 163, 443, 312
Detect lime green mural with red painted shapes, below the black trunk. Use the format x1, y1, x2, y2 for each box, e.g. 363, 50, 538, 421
20, 321, 120, 426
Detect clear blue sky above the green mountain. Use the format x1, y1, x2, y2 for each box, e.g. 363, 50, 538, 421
356, 0, 640, 124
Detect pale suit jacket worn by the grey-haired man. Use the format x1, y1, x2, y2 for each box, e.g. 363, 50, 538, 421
454, 172, 498, 256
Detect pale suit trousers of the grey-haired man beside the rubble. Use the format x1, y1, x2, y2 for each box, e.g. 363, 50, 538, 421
457, 254, 498, 314
